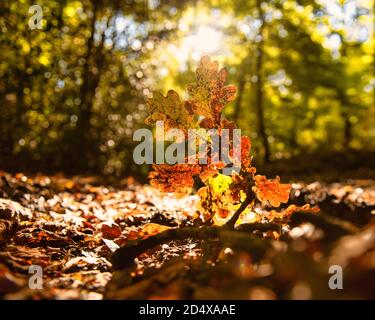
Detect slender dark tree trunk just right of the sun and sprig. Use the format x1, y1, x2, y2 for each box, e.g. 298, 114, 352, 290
255, 0, 270, 162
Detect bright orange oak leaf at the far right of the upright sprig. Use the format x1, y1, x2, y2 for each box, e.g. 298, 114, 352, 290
253, 175, 292, 207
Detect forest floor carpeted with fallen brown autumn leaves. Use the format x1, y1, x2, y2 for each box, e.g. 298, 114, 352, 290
0, 166, 375, 299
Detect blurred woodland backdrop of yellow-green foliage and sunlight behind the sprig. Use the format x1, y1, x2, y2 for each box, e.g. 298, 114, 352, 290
0, 0, 375, 180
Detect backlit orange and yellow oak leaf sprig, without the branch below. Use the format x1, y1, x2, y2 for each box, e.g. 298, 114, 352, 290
145, 56, 316, 228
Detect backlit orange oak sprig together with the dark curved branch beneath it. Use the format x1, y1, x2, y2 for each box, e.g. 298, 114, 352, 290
112, 56, 319, 269
